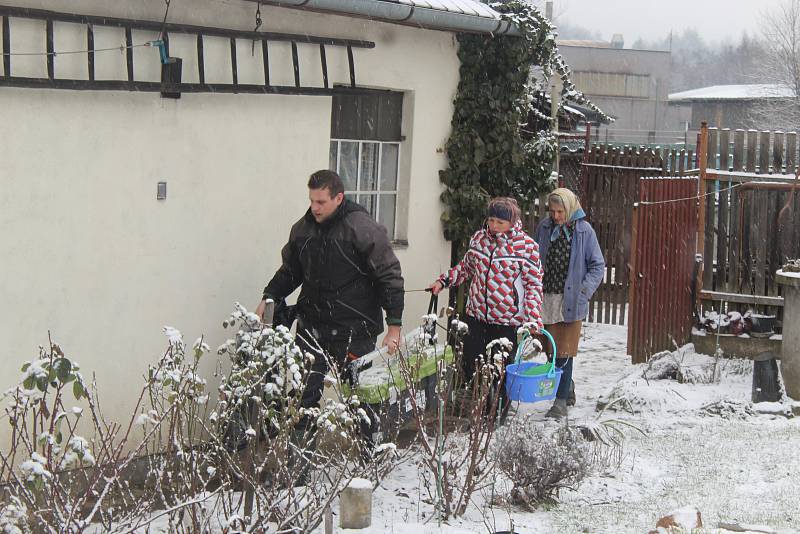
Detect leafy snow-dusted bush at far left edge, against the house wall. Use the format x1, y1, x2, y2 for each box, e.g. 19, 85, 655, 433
0, 342, 103, 532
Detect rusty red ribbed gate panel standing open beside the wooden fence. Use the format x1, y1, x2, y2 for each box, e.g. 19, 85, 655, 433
628, 177, 697, 363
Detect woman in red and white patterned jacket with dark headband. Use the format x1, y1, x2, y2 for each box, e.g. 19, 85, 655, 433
430, 197, 542, 394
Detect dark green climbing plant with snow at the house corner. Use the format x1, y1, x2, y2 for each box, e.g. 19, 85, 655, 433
439, 0, 599, 256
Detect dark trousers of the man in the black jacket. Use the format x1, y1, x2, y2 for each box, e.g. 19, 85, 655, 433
296, 324, 376, 434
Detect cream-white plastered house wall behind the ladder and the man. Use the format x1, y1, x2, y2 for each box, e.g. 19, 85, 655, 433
0, 0, 458, 444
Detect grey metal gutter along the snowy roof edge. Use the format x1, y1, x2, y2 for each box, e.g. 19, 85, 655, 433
250, 0, 520, 37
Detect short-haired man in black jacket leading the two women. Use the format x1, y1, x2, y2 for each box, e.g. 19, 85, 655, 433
256, 170, 404, 418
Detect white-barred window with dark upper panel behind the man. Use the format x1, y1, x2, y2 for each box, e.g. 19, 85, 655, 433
330, 91, 403, 239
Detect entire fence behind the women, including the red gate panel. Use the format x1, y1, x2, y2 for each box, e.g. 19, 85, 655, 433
532, 126, 800, 361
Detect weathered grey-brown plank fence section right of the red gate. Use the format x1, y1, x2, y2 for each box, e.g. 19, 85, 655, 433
699, 128, 800, 315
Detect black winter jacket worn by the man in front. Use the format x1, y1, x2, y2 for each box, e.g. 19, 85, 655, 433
264, 200, 404, 340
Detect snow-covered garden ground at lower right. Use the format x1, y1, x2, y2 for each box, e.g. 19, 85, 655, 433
344, 324, 800, 534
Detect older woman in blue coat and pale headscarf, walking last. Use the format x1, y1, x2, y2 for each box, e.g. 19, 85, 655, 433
536, 188, 605, 418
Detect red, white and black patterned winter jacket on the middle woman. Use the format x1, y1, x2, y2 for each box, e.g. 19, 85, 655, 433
439, 223, 542, 330
